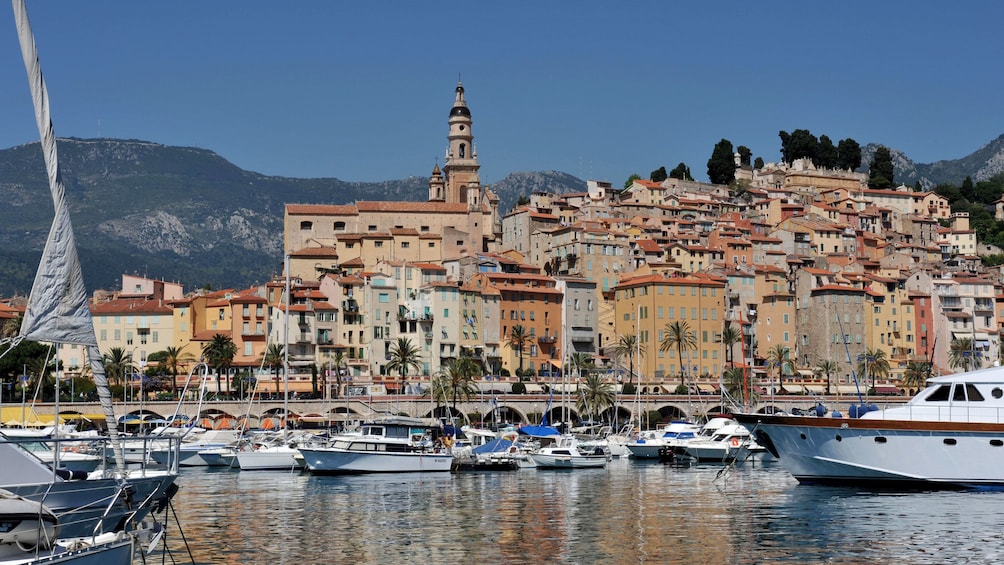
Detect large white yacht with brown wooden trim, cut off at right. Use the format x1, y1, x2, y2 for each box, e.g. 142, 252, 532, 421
735, 366, 1004, 488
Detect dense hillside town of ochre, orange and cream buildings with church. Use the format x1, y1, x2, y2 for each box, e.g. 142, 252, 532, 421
0, 84, 1004, 396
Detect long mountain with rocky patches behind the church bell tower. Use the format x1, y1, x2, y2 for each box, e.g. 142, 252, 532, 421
0, 138, 585, 296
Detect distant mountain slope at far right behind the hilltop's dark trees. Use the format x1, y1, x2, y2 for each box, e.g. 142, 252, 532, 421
858, 135, 1004, 189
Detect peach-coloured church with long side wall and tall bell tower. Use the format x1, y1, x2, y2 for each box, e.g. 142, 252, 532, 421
284, 83, 501, 280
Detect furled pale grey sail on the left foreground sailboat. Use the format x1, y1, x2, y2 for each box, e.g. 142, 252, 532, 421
11, 0, 124, 470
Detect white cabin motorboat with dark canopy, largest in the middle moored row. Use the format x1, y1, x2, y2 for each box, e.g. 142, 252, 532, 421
299, 416, 453, 474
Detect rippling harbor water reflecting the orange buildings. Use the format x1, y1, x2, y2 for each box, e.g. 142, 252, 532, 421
168, 460, 1004, 565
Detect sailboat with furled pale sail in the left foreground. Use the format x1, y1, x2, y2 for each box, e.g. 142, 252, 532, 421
0, 0, 178, 565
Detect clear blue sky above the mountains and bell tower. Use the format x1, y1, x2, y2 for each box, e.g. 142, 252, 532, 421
0, 0, 1004, 185
